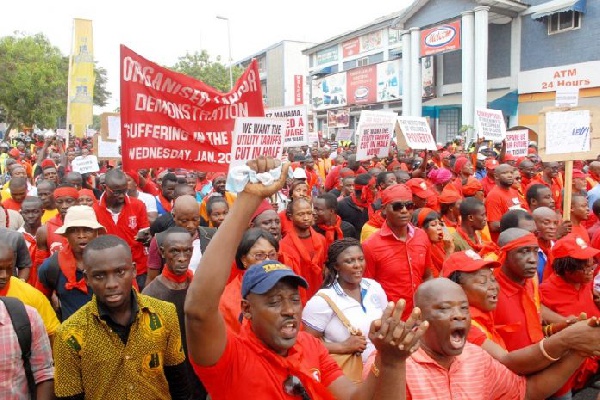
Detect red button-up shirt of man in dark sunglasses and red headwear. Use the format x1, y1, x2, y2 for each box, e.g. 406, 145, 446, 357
363, 223, 432, 319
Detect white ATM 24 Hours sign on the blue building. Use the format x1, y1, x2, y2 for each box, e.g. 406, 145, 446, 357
519, 61, 600, 93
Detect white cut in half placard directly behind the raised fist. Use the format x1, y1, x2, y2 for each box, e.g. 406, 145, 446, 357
228, 117, 287, 167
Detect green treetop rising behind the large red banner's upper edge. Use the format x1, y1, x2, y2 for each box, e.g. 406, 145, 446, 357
171, 50, 244, 92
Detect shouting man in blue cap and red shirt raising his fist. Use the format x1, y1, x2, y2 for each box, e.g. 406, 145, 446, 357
185, 157, 428, 400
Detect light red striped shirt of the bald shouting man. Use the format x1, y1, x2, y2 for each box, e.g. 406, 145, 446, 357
406, 343, 526, 400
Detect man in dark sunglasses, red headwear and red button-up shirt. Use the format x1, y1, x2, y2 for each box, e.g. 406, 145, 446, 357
363, 184, 432, 318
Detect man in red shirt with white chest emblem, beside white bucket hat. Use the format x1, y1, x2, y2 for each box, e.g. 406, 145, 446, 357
94, 169, 150, 290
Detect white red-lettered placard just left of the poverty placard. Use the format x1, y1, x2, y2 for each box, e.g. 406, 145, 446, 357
356, 110, 398, 161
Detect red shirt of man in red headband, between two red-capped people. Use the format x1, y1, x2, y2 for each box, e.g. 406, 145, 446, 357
494, 268, 544, 351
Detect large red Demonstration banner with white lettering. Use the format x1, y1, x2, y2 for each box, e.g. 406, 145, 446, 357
121, 45, 264, 172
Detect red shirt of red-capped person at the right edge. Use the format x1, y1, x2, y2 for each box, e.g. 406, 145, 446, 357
540, 274, 600, 318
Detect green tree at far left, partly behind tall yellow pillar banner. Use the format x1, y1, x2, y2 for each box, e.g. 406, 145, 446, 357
0, 33, 111, 130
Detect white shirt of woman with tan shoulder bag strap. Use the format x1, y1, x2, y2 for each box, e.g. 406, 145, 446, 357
302, 278, 387, 363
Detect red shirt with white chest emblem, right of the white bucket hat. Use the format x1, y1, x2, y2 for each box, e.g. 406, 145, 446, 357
94, 196, 150, 275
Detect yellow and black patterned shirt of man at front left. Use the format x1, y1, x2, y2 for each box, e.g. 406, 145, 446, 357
54, 294, 185, 400
